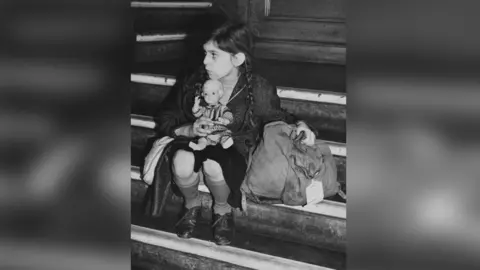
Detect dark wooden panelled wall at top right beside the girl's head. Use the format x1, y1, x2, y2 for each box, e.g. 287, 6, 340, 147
236, 0, 346, 65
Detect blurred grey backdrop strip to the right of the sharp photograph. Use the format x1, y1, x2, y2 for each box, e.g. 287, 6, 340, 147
347, 1, 480, 269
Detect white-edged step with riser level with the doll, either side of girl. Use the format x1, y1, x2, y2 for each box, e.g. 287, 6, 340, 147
130, 73, 346, 142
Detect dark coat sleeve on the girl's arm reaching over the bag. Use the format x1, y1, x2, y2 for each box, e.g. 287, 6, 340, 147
254, 78, 318, 136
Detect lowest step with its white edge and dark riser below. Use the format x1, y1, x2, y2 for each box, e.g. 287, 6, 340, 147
131, 225, 345, 269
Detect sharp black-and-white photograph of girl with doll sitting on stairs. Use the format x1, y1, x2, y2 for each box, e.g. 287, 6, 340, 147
130, 0, 347, 270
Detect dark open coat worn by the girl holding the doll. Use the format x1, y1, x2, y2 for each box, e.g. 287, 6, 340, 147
142, 68, 316, 215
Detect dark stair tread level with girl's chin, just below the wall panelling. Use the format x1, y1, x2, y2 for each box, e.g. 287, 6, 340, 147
132, 59, 346, 93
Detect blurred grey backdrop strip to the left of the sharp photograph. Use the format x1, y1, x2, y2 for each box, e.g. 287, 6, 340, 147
0, 0, 130, 269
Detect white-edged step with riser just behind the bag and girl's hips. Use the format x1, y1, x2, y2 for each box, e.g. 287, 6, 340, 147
131, 121, 347, 198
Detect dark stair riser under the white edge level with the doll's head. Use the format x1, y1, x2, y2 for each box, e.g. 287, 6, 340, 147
130, 82, 346, 141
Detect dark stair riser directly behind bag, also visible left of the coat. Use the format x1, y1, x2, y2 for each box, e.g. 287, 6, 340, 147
131, 127, 347, 188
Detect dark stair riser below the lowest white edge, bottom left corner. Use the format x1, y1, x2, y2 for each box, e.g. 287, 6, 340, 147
131, 241, 248, 270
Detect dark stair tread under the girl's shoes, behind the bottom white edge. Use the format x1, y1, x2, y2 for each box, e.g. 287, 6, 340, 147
132, 202, 346, 269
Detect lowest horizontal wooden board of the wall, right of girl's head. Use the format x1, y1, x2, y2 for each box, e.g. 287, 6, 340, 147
254, 41, 346, 65
